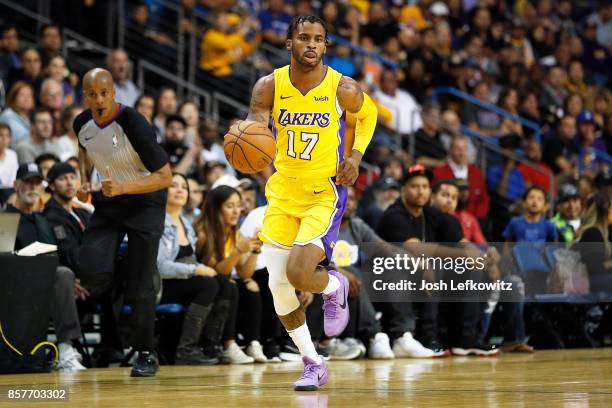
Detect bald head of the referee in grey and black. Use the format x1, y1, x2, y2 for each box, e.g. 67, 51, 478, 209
83, 68, 117, 122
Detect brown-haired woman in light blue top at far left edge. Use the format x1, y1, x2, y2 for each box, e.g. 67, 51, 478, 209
0, 81, 35, 147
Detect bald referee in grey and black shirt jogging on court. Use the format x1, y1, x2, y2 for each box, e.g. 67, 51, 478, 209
73, 68, 172, 377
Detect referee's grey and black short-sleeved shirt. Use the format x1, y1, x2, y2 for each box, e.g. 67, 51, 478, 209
73, 105, 168, 205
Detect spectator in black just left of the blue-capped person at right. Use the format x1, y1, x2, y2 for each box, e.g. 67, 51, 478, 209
543, 115, 578, 175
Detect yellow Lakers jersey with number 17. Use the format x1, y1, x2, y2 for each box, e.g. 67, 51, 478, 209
272, 65, 346, 179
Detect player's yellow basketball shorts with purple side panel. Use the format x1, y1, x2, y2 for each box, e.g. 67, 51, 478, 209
259, 172, 347, 259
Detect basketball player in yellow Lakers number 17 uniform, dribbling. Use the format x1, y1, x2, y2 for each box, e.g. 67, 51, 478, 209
241, 16, 377, 391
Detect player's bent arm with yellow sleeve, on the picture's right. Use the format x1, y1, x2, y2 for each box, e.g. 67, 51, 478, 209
336, 77, 378, 185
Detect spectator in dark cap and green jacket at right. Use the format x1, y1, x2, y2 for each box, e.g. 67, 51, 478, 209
550, 184, 582, 245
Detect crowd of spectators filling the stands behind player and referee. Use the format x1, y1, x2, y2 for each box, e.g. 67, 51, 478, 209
0, 0, 612, 370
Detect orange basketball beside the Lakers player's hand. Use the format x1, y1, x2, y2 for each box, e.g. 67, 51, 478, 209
223, 120, 276, 174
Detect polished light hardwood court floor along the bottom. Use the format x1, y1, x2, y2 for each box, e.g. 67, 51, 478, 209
0, 348, 612, 408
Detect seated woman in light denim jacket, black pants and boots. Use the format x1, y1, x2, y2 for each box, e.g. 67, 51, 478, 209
157, 174, 221, 365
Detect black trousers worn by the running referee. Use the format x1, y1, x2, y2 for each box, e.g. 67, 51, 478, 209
79, 203, 166, 351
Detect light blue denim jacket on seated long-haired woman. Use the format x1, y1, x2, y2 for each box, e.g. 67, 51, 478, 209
157, 213, 200, 279
